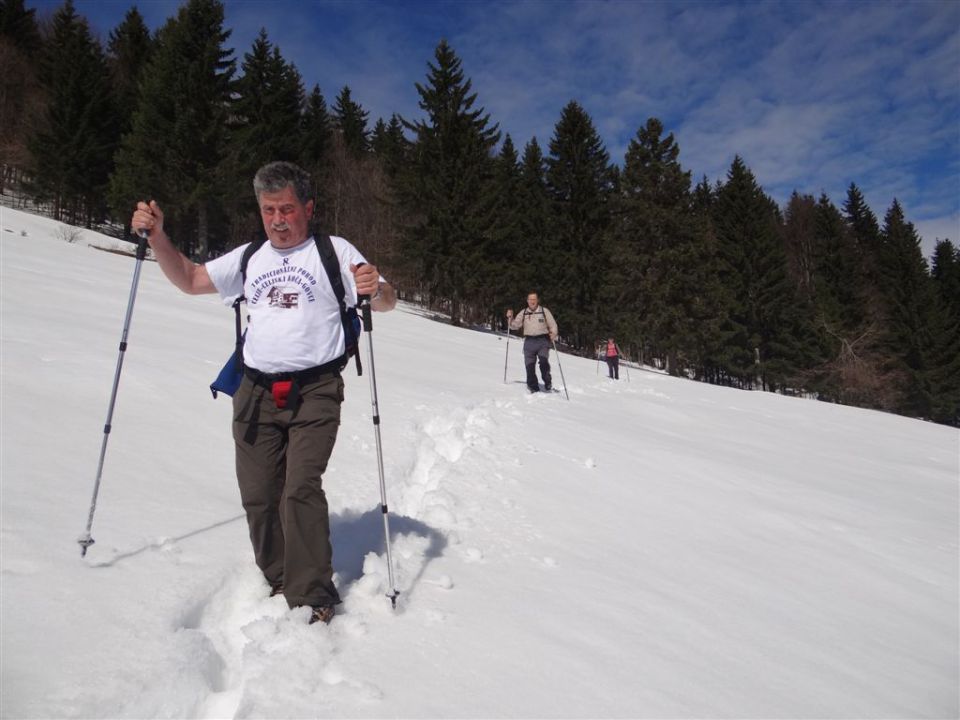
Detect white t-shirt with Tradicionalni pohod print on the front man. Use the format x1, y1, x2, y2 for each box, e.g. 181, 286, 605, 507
206, 236, 366, 373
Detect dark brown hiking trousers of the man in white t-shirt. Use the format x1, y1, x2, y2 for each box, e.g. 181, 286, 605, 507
233, 373, 343, 608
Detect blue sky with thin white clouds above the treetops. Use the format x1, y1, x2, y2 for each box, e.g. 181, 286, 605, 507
27, 0, 960, 256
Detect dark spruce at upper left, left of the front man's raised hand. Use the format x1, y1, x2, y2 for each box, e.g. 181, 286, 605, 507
29, 0, 118, 225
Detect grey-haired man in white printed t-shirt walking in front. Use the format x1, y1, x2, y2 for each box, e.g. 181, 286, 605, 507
130, 162, 397, 623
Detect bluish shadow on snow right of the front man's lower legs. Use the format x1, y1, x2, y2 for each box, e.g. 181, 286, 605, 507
330, 505, 447, 592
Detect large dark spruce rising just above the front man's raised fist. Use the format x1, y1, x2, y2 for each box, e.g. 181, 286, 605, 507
110, 0, 235, 259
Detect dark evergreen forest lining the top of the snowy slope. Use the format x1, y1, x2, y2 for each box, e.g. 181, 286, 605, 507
0, 0, 960, 426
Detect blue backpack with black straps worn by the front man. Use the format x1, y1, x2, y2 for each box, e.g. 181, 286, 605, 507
210, 235, 363, 397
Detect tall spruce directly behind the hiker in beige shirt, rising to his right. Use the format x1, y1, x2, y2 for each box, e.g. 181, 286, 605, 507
539, 101, 616, 349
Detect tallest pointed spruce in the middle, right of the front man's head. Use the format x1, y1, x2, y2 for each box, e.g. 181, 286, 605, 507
402, 40, 500, 324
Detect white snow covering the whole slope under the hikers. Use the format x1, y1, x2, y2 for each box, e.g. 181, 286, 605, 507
0, 208, 960, 718
